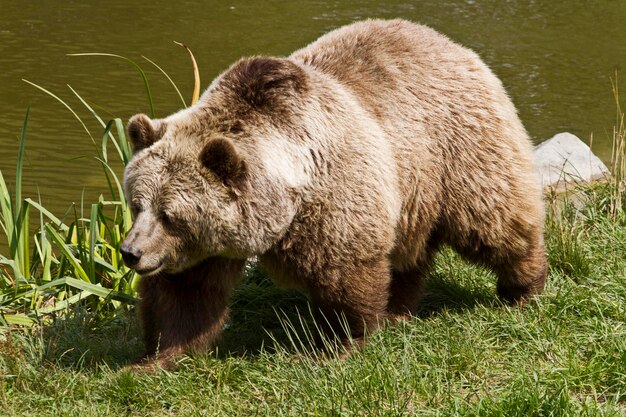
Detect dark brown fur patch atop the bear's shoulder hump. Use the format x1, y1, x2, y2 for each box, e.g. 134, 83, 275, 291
226, 57, 308, 108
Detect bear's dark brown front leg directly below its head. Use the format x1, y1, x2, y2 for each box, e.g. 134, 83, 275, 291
138, 258, 244, 364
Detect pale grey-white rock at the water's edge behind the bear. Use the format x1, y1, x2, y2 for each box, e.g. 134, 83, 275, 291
534, 132, 609, 188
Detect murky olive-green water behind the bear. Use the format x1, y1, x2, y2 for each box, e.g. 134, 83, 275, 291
0, 0, 626, 218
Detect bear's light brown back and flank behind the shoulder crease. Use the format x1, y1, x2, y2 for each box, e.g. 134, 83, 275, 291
290, 20, 542, 264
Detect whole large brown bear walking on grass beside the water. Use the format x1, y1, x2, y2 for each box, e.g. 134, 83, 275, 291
121, 20, 547, 364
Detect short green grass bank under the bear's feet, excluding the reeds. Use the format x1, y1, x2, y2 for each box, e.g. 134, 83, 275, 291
0, 180, 626, 416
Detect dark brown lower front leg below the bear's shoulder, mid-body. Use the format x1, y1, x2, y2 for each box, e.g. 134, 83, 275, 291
312, 259, 390, 346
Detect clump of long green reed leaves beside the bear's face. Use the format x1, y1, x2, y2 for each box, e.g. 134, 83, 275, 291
0, 47, 200, 331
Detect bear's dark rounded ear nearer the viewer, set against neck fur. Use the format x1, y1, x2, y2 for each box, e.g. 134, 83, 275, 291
200, 138, 247, 188
